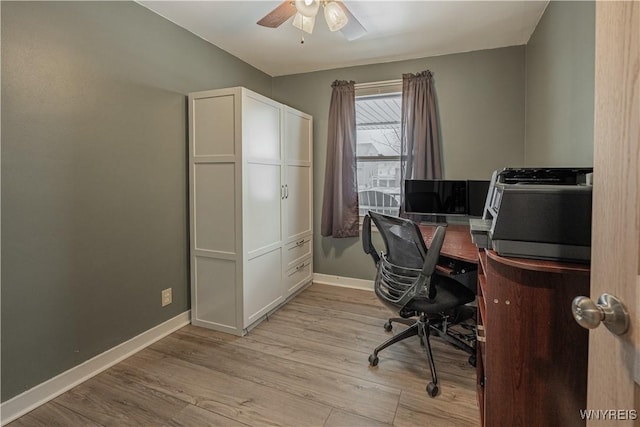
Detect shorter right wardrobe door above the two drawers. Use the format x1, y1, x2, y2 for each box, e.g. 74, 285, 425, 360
283, 107, 313, 243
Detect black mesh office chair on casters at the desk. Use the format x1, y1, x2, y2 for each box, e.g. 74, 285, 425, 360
362, 212, 475, 397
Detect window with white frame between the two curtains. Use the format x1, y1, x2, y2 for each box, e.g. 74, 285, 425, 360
356, 80, 402, 216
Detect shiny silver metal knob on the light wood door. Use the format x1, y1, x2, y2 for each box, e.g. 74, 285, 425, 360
571, 293, 629, 335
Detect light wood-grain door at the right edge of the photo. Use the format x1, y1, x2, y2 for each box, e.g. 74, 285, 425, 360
585, 1, 640, 426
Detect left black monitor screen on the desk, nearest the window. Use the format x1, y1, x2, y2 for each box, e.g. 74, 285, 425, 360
404, 179, 467, 215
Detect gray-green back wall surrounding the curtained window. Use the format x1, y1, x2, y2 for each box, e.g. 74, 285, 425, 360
273, 46, 525, 279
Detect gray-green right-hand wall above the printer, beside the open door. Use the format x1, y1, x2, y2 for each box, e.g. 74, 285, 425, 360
525, 1, 595, 166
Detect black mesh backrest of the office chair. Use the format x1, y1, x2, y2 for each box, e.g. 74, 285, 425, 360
363, 212, 446, 308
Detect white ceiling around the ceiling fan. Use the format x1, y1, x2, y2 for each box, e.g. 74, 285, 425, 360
139, 0, 548, 76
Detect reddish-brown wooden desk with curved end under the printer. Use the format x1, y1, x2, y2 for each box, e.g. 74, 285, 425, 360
420, 224, 590, 427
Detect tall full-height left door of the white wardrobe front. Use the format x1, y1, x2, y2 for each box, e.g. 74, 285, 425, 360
242, 90, 284, 329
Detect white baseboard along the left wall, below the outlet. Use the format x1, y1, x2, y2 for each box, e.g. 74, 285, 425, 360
0, 311, 191, 425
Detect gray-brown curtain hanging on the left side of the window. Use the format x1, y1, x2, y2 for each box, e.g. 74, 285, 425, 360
320, 80, 359, 237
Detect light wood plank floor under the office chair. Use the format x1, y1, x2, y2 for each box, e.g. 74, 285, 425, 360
9, 284, 479, 427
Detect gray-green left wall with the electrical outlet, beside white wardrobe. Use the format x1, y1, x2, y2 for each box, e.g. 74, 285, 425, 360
1, 2, 272, 401
